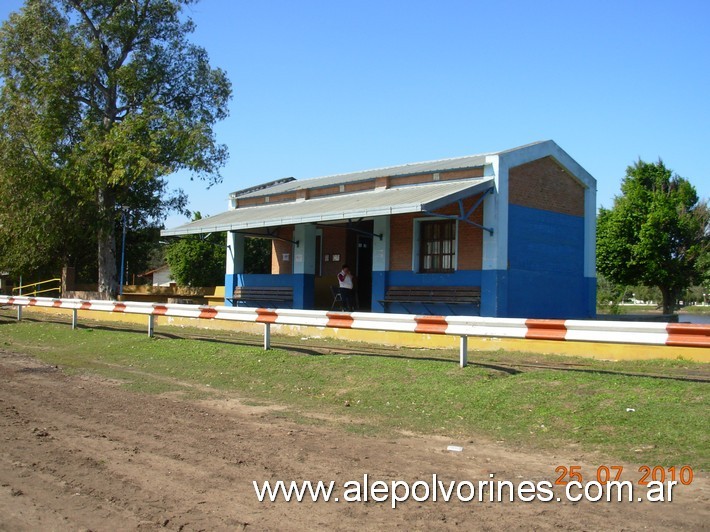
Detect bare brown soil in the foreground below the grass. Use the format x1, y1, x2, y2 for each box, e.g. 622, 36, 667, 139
0, 351, 710, 531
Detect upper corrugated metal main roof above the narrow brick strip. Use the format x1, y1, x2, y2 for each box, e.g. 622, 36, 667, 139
230, 154, 496, 198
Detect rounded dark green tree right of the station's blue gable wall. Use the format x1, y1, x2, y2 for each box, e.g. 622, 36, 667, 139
597, 160, 708, 314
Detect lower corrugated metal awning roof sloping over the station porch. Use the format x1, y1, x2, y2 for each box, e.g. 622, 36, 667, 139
161, 177, 493, 236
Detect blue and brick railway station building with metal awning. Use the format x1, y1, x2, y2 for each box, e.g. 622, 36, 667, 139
162, 140, 596, 318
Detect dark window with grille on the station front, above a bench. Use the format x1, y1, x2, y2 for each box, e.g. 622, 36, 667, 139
419, 220, 456, 273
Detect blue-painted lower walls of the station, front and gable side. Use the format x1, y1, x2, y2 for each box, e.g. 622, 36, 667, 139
225, 205, 596, 318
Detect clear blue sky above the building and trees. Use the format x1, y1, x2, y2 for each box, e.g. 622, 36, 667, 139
0, 0, 710, 227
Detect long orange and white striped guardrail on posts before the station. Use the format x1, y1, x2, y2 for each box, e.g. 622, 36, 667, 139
0, 296, 710, 367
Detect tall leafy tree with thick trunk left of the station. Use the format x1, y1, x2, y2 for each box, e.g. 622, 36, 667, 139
0, 0, 231, 295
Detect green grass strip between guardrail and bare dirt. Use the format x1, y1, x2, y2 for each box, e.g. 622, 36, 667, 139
0, 315, 710, 470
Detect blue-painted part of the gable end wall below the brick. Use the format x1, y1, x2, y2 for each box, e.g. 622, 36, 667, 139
508, 205, 593, 318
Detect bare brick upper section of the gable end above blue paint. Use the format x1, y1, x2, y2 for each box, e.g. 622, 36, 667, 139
508, 157, 584, 216
